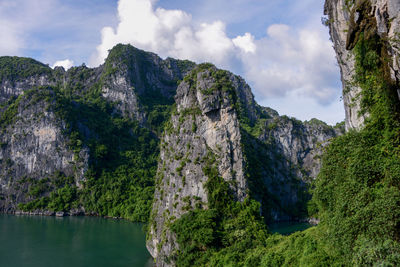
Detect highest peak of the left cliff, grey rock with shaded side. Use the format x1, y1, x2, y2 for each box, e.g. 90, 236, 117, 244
102, 44, 195, 124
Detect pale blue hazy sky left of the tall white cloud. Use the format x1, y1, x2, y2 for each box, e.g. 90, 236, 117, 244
0, 0, 117, 65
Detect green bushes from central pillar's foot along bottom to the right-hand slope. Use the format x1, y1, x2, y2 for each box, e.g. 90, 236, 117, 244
167, 148, 335, 267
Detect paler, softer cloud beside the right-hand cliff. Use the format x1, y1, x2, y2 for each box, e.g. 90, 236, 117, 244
241, 24, 340, 104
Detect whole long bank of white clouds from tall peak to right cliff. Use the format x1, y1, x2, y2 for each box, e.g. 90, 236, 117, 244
90, 0, 340, 105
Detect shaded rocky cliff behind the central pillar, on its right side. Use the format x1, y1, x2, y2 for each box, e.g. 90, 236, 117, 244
243, 111, 344, 222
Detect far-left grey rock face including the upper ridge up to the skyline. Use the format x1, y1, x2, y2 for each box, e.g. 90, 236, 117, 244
0, 57, 88, 212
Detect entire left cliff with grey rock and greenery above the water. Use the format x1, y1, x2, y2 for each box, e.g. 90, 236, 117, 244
0, 45, 194, 216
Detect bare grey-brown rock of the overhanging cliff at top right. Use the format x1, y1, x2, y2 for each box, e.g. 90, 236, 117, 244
325, 0, 400, 130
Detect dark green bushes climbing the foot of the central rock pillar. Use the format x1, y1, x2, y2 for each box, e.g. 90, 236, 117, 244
169, 151, 267, 266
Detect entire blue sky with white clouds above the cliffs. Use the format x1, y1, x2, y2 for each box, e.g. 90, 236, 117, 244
0, 0, 344, 125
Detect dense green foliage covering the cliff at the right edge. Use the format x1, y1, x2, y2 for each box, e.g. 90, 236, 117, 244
313, 30, 400, 266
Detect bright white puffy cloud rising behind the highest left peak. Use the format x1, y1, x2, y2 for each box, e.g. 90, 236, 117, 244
90, 0, 247, 67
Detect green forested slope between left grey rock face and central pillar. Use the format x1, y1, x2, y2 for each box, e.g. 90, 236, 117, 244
15, 77, 159, 222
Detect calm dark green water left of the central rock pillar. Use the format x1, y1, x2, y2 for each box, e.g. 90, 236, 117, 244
0, 214, 153, 267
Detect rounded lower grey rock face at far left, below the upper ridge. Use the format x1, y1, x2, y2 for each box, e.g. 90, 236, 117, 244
0, 88, 89, 212
